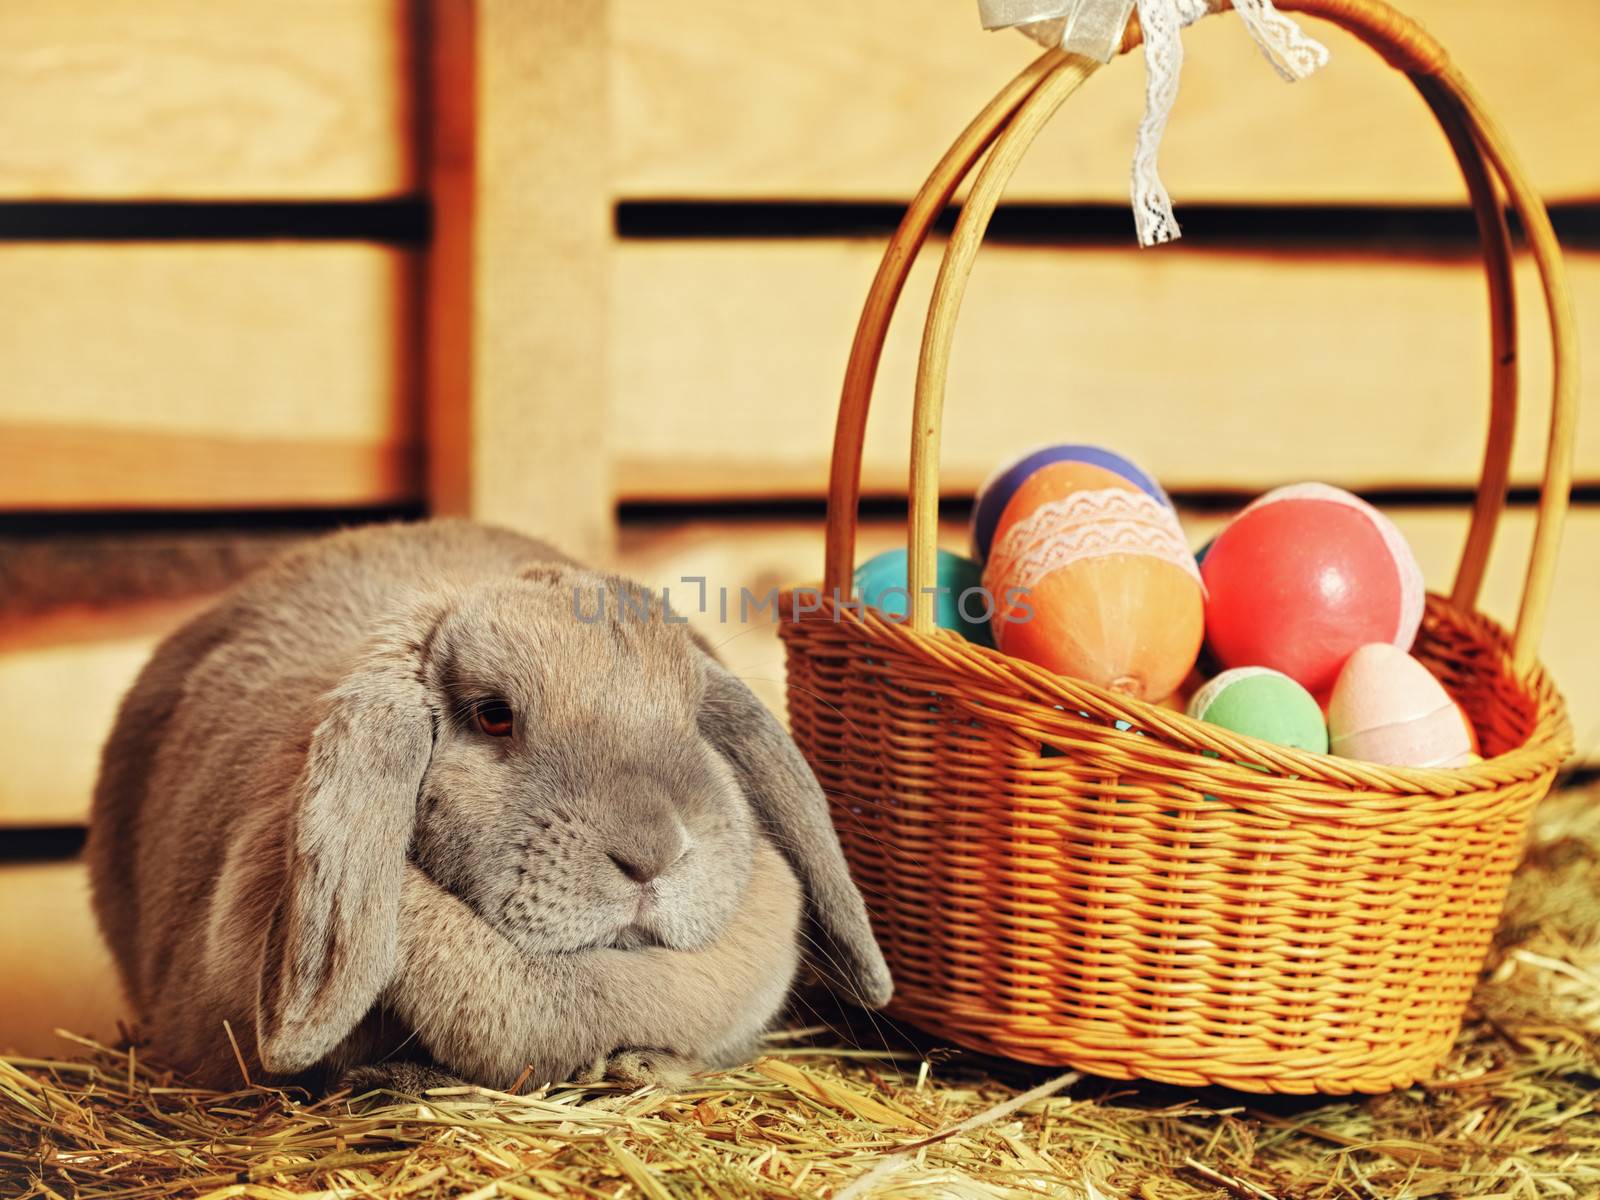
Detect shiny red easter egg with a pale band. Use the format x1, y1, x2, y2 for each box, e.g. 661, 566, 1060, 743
1200, 483, 1424, 691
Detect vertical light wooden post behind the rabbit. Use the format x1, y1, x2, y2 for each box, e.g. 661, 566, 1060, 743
426, 0, 613, 557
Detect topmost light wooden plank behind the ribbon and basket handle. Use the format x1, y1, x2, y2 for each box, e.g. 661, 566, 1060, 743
613, 0, 1600, 202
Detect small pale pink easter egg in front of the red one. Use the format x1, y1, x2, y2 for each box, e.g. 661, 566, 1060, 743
1328, 642, 1472, 766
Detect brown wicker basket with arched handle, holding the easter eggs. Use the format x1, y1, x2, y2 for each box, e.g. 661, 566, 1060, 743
781, 0, 1576, 1093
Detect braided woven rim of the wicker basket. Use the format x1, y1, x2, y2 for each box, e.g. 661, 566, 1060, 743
779, 584, 1573, 803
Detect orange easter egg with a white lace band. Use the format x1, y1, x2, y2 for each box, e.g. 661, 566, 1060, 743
984, 480, 1205, 701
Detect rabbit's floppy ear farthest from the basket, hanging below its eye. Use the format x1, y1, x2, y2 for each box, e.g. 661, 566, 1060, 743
256, 606, 443, 1075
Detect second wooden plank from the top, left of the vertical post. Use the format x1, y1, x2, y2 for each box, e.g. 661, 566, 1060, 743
0, 243, 421, 509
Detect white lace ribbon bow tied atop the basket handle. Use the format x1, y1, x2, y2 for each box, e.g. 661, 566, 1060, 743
978, 0, 1328, 246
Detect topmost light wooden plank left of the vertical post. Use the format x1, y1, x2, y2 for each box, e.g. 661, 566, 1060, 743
0, 0, 418, 200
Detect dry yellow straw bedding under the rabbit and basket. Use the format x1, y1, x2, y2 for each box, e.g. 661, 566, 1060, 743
0, 789, 1600, 1200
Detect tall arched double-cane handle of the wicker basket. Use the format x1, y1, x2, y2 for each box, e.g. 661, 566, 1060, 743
824, 0, 1578, 669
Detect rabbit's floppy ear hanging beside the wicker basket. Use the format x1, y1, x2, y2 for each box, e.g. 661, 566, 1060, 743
699, 654, 893, 1008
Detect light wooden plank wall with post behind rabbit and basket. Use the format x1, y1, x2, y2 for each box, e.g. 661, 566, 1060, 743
0, 0, 1600, 1048
